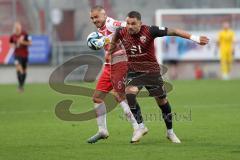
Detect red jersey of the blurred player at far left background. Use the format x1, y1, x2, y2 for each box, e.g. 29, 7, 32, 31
10, 31, 30, 57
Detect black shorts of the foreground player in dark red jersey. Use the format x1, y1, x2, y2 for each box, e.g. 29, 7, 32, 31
126, 72, 167, 98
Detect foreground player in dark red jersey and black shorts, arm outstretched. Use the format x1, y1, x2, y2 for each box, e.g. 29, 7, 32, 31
110, 11, 209, 143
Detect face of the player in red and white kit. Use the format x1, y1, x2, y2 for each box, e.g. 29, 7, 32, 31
90, 10, 107, 28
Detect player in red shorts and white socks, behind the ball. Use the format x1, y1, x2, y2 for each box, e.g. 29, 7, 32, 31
88, 6, 147, 143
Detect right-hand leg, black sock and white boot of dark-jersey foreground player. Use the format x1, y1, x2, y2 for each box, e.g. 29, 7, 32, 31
155, 97, 181, 143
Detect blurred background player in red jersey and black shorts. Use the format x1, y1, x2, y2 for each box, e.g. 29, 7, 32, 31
10, 22, 32, 92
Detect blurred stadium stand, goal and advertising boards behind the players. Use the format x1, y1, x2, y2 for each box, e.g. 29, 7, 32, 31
0, 0, 240, 84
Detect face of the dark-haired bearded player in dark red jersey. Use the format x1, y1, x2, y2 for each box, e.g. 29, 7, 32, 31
126, 17, 142, 34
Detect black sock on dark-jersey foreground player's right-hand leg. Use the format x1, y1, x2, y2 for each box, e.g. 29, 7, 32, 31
159, 102, 172, 129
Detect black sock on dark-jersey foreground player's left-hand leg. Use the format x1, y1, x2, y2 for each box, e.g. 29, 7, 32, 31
126, 94, 143, 124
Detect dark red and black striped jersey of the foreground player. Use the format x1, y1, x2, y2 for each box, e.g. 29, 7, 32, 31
116, 25, 167, 72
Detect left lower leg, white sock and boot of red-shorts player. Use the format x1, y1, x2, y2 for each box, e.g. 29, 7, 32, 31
87, 90, 109, 143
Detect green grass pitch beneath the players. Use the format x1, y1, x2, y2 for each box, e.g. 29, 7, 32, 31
0, 80, 240, 160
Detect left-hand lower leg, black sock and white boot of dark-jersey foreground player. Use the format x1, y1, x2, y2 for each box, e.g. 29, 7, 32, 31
125, 86, 148, 143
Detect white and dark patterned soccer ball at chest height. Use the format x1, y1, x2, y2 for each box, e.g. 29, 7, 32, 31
87, 32, 105, 50
